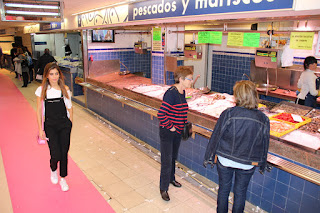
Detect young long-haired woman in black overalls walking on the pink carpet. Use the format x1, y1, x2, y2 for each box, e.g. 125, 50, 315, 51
35, 62, 73, 191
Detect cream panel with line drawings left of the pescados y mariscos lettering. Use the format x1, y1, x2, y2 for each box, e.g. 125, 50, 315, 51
78, 5, 128, 27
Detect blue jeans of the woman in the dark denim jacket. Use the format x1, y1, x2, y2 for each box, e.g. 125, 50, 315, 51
217, 160, 255, 213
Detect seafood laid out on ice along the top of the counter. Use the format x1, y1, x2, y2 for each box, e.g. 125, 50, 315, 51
127, 84, 320, 149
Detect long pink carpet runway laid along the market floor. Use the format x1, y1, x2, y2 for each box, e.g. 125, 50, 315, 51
0, 74, 114, 213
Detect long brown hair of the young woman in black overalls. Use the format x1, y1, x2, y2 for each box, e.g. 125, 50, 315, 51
40, 62, 69, 100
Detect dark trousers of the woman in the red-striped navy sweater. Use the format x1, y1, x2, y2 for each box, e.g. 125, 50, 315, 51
160, 127, 181, 191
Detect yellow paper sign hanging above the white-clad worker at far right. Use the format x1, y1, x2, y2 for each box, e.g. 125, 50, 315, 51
290, 32, 314, 50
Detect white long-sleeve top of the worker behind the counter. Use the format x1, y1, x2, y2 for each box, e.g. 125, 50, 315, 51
298, 69, 318, 100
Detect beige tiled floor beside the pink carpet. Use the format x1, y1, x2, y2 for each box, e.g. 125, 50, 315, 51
0, 69, 220, 213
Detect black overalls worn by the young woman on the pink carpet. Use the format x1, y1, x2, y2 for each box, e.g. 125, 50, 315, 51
44, 92, 72, 177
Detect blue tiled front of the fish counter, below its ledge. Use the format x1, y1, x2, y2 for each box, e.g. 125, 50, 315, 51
87, 89, 320, 213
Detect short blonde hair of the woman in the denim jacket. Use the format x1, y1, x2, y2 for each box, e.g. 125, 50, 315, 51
233, 81, 259, 109
